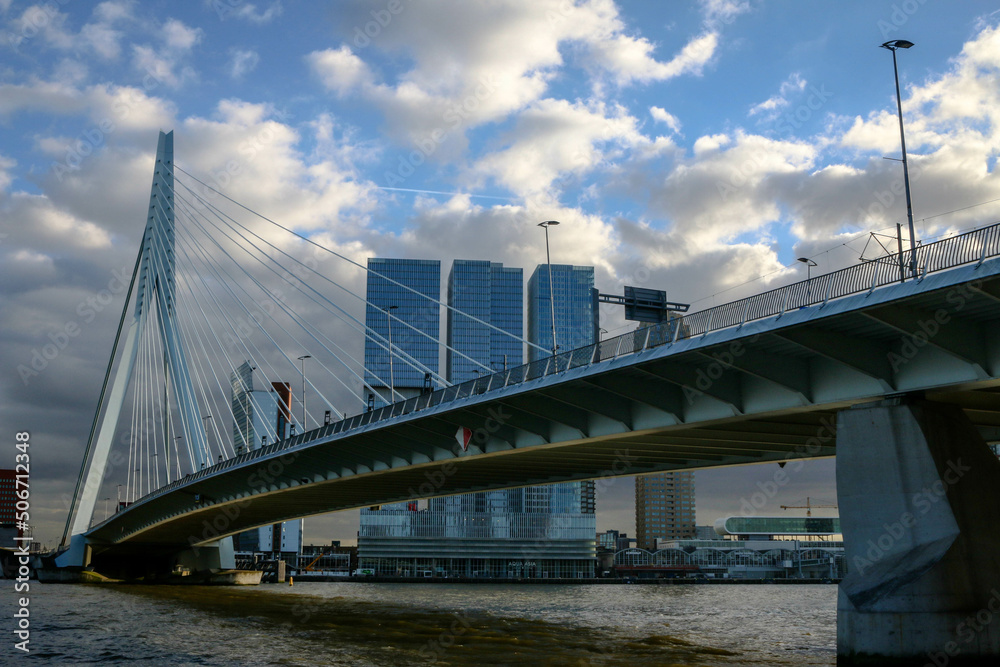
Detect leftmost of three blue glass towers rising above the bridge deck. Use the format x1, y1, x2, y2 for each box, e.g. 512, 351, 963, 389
365, 257, 441, 407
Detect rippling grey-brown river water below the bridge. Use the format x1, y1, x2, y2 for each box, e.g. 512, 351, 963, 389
0, 581, 837, 667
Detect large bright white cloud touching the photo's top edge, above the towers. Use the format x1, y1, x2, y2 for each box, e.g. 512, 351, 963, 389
332, 0, 718, 160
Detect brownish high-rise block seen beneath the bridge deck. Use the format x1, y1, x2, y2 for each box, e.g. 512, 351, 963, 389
635, 471, 695, 549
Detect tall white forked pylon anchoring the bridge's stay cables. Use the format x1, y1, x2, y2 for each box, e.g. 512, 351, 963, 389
57, 132, 211, 567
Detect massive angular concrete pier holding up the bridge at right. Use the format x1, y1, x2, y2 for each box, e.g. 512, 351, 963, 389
837, 399, 1000, 667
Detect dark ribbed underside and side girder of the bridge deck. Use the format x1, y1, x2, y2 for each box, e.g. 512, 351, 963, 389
87, 261, 1000, 553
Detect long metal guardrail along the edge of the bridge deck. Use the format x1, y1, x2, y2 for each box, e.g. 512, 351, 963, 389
121, 223, 1000, 525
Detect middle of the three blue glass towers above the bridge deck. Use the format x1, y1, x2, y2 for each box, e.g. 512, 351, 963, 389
446, 259, 524, 383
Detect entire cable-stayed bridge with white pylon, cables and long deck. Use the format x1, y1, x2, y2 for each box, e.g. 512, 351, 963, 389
50, 134, 1000, 664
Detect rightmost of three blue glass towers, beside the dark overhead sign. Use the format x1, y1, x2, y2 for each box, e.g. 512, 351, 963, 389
528, 264, 600, 361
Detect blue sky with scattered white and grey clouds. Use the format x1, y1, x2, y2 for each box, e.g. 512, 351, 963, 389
0, 0, 1000, 543
